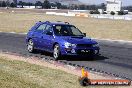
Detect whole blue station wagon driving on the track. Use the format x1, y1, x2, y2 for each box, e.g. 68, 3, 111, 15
26, 21, 100, 60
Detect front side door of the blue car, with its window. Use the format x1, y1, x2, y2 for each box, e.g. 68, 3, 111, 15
43, 25, 54, 52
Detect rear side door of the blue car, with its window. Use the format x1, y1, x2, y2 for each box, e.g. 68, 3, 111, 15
32, 24, 46, 49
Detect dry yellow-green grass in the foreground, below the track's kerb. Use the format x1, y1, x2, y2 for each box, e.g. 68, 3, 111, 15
0, 56, 120, 88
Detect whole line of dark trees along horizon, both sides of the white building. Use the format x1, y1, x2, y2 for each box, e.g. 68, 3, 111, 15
0, 0, 132, 11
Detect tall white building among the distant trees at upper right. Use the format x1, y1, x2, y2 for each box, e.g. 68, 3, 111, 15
106, 0, 122, 13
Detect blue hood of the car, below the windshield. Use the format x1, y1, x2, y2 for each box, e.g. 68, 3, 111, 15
60, 36, 97, 44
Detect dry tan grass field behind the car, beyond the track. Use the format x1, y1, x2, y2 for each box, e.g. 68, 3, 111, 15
0, 12, 132, 41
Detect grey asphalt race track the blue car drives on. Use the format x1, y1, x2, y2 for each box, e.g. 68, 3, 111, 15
0, 32, 132, 80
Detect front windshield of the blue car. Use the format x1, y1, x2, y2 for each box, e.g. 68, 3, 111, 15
53, 25, 84, 36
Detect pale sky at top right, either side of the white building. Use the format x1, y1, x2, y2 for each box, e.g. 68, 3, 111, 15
79, 0, 132, 6
